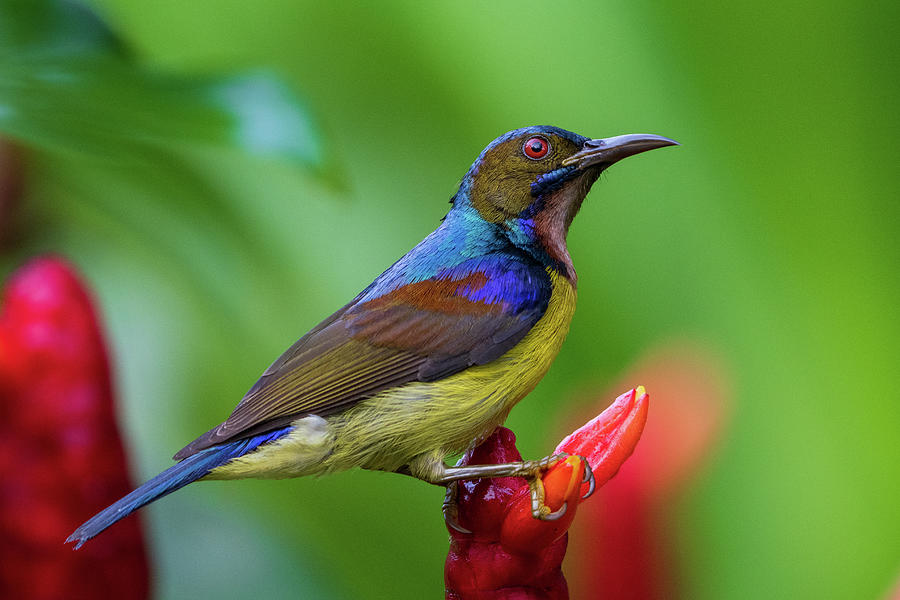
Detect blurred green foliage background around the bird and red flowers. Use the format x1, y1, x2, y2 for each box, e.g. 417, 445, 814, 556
0, 0, 900, 599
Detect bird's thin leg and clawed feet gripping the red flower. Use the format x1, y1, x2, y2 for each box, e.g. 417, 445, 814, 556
403, 453, 568, 533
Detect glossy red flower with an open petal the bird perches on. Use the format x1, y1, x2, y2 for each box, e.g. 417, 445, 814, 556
444, 388, 649, 600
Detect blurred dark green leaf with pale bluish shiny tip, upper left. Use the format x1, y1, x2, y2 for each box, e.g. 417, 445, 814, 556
0, 1, 322, 167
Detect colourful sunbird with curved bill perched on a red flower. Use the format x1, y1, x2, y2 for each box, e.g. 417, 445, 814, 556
66, 126, 678, 549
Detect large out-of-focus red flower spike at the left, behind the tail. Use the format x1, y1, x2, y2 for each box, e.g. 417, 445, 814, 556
0, 258, 148, 599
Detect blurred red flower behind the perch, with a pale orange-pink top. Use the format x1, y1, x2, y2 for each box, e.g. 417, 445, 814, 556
566, 343, 729, 600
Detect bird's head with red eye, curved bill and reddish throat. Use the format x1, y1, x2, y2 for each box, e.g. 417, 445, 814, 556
454, 126, 677, 278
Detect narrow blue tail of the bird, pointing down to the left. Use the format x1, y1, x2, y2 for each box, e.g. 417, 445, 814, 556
66, 427, 292, 550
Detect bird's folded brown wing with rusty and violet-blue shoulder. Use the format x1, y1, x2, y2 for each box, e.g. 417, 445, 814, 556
169, 257, 552, 459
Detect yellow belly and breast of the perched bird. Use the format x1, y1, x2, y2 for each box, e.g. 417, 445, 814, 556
209, 269, 576, 479
